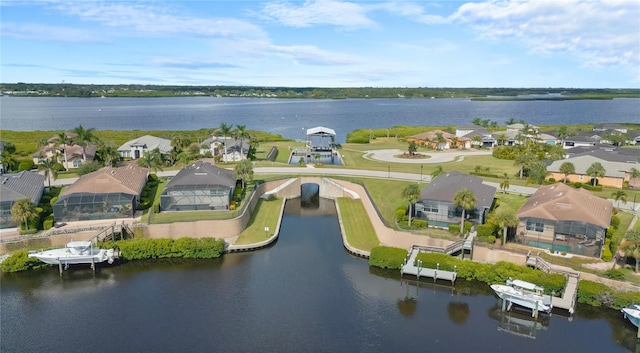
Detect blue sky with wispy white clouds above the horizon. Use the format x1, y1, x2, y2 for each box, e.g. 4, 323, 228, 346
0, 0, 640, 88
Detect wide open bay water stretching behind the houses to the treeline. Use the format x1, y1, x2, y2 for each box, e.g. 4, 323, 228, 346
0, 96, 640, 142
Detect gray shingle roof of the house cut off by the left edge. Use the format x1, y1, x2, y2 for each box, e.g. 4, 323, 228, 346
0, 170, 45, 204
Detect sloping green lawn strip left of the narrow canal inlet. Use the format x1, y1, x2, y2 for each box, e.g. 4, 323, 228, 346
235, 198, 284, 245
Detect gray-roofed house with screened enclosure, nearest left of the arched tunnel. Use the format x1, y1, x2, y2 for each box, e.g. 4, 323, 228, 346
160, 161, 236, 211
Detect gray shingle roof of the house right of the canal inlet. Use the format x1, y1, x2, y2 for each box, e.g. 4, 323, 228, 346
420, 171, 496, 208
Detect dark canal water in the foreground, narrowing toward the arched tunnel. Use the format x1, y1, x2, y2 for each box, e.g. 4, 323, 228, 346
0, 199, 640, 353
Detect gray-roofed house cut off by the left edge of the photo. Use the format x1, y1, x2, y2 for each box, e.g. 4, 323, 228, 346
0, 170, 45, 229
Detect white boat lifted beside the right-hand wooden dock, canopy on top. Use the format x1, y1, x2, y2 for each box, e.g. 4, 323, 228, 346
491, 279, 553, 313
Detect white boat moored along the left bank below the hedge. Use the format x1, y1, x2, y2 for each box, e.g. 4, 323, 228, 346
29, 241, 115, 265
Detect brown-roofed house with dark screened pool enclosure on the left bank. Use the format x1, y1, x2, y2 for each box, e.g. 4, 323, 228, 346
53, 163, 149, 222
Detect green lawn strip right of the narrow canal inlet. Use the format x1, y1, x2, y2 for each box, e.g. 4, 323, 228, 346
337, 197, 380, 251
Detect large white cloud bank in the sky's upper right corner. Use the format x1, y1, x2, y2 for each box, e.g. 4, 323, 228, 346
451, 0, 640, 70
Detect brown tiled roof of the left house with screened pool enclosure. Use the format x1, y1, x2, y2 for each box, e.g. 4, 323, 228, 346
60, 164, 149, 196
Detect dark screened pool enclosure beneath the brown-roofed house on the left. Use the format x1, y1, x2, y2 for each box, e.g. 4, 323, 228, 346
53, 192, 137, 222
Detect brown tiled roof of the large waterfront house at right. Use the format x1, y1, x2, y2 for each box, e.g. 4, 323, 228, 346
516, 183, 613, 228
